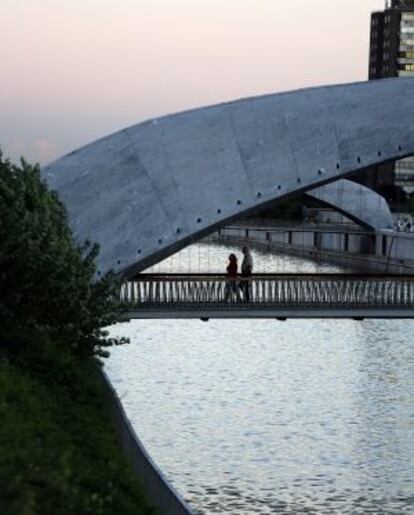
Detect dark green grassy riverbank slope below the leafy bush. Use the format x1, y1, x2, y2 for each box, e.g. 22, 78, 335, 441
0, 339, 156, 515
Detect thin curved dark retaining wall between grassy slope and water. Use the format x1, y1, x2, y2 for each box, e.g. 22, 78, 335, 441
102, 370, 193, 515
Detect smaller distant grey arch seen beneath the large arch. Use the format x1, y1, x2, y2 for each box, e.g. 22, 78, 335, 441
306, 179, 394, 231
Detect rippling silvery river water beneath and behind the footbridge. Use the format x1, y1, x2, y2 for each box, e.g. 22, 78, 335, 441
106, 245, 414, 515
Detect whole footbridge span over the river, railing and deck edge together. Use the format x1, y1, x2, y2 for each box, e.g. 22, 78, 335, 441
121, 274, 414, 320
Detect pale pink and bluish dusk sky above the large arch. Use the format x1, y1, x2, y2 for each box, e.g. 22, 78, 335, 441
0, 0, 385, 164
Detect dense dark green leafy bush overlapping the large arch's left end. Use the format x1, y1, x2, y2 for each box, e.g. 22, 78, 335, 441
0, 153, 128, 356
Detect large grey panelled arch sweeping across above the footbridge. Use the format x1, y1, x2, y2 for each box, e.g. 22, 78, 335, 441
44, 78, 414, 275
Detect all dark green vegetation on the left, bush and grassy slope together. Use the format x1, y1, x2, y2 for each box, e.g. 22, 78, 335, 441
0, 154, 154, 515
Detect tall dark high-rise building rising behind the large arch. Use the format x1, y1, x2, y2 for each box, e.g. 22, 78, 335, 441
368, 0, 414, 197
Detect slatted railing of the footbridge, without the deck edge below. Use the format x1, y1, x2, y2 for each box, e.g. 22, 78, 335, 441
121, 274, 414, 309
